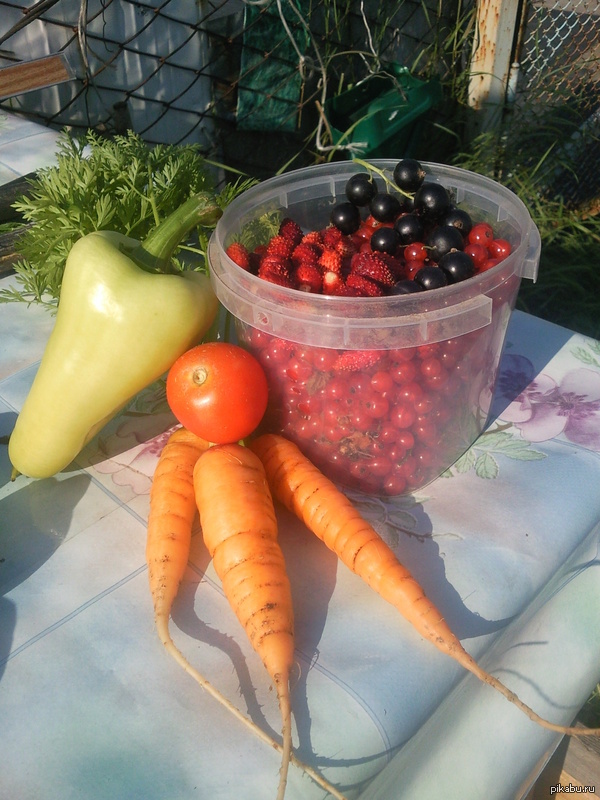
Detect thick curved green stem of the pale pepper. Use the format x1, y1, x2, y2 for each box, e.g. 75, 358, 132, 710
127, 192, 223, 273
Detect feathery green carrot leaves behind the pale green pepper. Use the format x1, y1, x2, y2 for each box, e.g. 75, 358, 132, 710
0, 131, 254, 309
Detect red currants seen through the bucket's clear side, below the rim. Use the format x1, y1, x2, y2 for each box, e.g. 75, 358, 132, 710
238, 318, 510, 495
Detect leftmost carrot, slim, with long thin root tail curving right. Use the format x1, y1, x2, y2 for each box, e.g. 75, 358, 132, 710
146, 428, 346, 800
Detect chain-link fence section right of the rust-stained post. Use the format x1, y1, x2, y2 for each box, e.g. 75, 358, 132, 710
509, 0, 600, 205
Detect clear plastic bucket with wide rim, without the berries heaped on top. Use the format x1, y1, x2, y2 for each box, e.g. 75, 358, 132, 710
208, 160, 540, 496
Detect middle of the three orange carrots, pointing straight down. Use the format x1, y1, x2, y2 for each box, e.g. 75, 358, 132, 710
194, 444, 294, 800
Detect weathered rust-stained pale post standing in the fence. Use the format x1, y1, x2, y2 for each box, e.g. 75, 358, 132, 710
469, 0, 519, 133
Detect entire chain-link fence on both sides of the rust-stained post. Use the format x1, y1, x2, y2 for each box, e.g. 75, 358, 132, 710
0, 0, 600, 197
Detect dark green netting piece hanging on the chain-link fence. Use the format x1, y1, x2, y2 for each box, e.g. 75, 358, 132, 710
237, 1, 309, 132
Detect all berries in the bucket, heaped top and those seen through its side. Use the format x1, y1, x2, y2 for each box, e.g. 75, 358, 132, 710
221, 159, 519, 496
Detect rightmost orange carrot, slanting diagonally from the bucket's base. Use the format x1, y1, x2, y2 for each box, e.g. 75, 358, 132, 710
250, 434, 600, 736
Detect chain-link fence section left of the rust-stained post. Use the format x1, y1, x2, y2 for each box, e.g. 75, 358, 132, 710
0, 0, 458, 175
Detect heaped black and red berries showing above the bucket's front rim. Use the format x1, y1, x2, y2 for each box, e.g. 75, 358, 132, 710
226, 159, 511, 297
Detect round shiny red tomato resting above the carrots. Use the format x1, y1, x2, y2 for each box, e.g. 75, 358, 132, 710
167, 342, 268, 444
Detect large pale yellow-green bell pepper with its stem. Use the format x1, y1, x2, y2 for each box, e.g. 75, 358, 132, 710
9, 192, 221, 478
